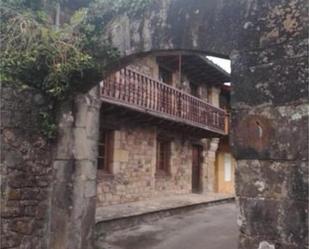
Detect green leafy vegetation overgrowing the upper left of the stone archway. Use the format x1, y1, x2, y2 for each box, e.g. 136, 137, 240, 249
0, 0, 150, 138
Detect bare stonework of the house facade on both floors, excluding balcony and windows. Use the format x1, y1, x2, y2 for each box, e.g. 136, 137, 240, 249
97, 55, 220, 206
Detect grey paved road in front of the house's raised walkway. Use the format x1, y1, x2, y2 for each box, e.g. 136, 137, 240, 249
99, 203, 238, 249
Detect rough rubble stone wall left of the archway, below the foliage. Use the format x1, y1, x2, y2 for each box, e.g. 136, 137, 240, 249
0, 86, 51, 249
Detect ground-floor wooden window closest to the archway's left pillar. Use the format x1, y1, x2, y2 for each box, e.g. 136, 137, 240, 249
98, 129, 113, 173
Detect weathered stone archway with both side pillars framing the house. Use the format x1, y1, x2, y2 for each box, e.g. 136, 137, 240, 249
4, 0, 308, 249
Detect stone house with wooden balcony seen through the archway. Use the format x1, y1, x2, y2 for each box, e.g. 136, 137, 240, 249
97, 54, 234, 206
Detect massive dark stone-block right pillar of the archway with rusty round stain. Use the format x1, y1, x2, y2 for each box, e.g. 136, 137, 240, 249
231, 0, 309, 249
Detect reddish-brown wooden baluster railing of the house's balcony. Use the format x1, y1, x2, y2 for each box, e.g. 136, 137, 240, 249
101, 68, 226, 134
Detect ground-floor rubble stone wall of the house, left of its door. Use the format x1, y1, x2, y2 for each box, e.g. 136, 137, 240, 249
97, 117, 192, 206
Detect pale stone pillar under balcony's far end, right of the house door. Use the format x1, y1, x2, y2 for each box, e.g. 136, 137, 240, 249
202, 138, 219, 193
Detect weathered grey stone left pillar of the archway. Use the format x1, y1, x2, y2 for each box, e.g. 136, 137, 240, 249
49, 88, 100, 249
